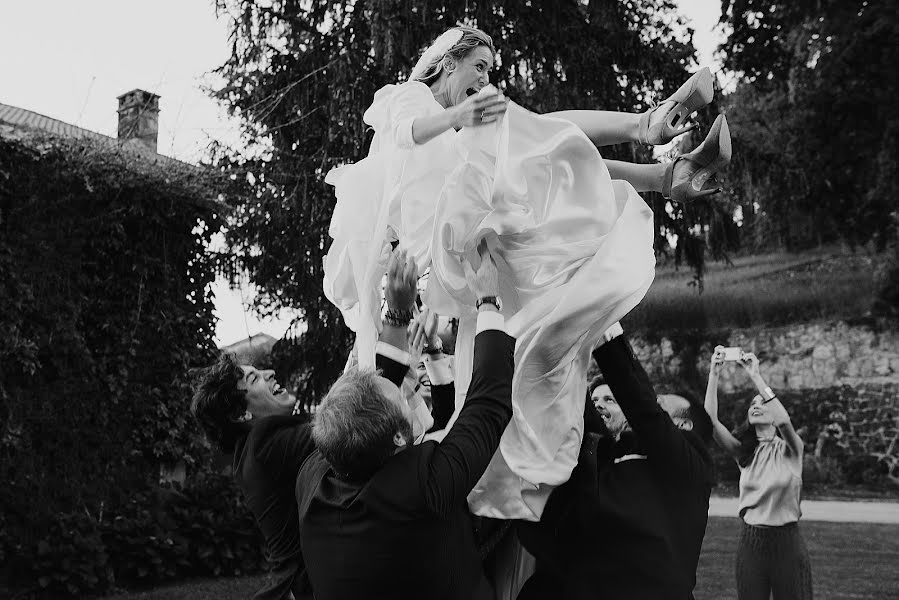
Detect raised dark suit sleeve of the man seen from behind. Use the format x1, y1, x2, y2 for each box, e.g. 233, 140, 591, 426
424, 330, 515, 517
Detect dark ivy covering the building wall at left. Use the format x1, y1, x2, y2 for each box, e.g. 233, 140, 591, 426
0, 132, 221, 537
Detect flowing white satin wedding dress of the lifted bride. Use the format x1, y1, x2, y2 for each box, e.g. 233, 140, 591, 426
325, 82, 655, 520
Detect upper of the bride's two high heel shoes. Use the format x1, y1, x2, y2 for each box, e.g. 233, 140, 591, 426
637, 67, 715, 146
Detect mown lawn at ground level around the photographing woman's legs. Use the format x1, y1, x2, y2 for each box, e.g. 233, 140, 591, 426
107, 517, 899, 600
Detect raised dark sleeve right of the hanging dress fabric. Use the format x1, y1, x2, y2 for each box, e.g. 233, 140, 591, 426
593, 335, 709, 481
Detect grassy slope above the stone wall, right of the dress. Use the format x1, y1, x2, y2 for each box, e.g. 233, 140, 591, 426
624, 248, 883, 332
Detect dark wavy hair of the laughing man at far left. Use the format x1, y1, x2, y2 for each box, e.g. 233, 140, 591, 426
190, 352, 247, 452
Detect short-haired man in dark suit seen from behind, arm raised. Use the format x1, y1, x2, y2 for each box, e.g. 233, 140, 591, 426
297, 247, 515, 600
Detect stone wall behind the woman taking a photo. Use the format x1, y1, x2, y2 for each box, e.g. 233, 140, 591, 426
631, 322, 899, 490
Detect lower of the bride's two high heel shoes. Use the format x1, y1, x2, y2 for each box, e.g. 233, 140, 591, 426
662, 115, 731, 202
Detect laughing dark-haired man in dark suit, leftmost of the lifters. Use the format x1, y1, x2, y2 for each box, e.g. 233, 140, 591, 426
191, 250, 444, 600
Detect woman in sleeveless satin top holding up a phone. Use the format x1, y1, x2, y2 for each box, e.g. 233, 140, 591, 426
705, 346, 812, 600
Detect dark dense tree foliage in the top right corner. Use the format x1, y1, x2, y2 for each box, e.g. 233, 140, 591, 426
722, 0, 899, 250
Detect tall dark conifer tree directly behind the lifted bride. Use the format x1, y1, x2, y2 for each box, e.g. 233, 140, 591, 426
214, 0, 715, 397
